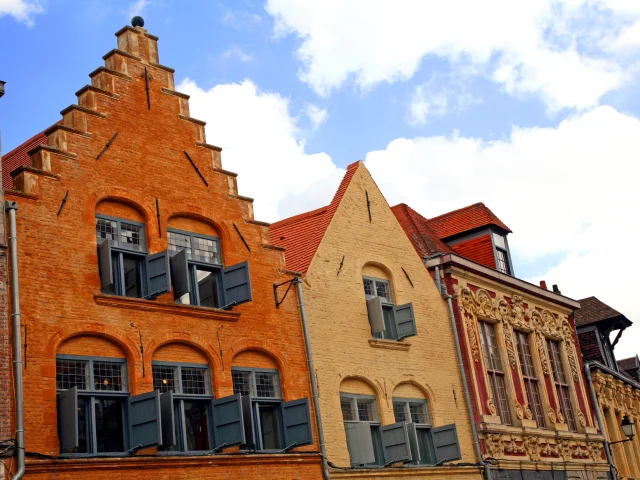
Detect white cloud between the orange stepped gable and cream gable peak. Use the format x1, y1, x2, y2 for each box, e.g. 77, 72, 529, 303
178, 79, 344, 221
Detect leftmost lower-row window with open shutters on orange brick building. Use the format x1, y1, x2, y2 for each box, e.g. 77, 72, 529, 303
56, 355, 162, 455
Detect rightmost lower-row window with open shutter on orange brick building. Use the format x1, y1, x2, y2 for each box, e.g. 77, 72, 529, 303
231, 367, 313, 451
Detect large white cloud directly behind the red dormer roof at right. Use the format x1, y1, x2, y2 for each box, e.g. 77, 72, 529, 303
365, 107, 640, 358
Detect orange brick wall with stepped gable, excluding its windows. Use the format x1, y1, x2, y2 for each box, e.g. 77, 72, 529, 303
0, 23, 321, 480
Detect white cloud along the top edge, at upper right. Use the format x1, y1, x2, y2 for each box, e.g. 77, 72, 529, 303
266, 0, 640, 112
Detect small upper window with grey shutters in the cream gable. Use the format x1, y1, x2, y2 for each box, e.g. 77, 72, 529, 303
362, 277, 417, 340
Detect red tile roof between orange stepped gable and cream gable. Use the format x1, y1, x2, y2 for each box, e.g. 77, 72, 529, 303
269, 161, 362, 274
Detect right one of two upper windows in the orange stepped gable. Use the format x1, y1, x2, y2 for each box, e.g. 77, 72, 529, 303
167, 229, 252, 308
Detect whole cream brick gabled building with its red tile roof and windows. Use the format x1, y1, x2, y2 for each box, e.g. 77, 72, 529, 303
271, 162, 481, 479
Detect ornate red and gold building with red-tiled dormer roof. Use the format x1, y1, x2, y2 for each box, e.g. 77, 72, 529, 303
394, 205, 609, 480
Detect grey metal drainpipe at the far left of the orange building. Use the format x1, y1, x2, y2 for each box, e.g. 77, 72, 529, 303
4, 201, 25, 480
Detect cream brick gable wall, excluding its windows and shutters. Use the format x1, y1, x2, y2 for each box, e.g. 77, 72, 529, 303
303, 164, 480, 478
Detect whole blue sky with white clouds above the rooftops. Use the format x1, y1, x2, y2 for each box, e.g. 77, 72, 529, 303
0, 0, 640, 354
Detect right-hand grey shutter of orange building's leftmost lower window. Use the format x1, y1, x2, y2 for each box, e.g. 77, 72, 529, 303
128, 390, 162, 448
